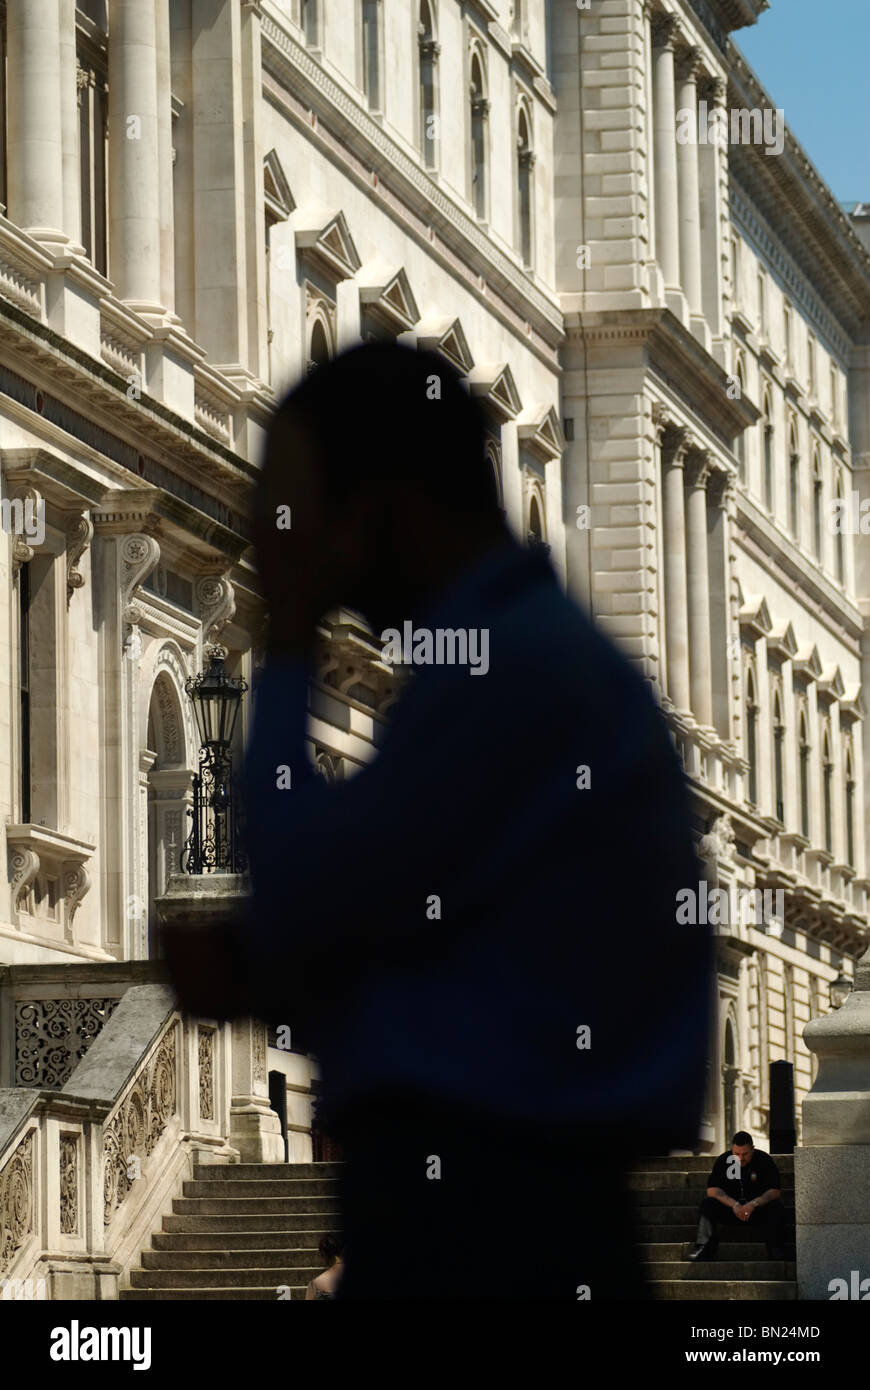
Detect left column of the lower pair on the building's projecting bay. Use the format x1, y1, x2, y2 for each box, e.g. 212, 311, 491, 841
657, 416, 691, 710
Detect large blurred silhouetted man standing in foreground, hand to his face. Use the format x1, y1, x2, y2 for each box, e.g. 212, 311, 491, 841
167, 345, 709, 1300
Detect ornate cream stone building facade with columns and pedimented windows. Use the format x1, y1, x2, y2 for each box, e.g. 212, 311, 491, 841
0, 0, 870, 1159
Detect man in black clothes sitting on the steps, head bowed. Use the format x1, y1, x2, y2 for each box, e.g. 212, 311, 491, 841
689, 1130, 785, 1259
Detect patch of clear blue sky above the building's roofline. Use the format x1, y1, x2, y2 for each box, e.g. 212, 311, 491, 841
731, 0, 870, 202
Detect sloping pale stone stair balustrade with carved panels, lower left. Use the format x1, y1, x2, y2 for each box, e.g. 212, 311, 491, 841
0, 984, 239, 1300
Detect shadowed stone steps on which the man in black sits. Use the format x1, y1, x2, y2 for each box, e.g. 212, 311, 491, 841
628, 1154, 798, 1301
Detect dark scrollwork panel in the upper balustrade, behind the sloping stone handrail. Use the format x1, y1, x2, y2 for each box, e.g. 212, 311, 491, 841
15, 999, 121, 1090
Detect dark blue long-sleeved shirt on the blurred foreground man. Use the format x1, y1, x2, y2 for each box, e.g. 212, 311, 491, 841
234, 546, 710, 1152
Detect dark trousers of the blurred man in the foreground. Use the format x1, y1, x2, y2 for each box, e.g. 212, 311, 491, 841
332, 1095, 648, 1302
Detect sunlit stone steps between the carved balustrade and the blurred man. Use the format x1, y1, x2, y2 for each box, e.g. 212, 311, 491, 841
120, 1163, 342, 1301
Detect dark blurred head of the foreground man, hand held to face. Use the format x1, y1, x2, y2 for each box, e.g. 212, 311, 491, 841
256, 343, 510, 644
